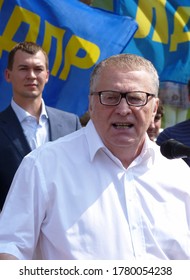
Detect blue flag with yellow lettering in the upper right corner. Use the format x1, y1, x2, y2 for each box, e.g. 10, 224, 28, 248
114, 0, 190, 84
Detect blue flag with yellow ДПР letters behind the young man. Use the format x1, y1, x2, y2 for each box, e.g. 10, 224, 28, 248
0, 0, 137, 116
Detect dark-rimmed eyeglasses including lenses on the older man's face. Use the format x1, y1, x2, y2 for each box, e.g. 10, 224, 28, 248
91, 90, 155, 107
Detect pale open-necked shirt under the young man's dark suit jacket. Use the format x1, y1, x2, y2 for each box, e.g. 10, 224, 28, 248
11, 99, 49, 150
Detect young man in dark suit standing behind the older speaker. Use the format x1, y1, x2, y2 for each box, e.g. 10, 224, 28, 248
0, 42, 81, 211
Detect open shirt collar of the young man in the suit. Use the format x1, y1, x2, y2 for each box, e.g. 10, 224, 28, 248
11, 99, 48, 123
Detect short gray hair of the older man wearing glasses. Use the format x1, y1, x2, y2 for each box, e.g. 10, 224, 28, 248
90, 53, 159, 96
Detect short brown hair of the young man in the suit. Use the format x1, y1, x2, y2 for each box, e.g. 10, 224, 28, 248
7, 41, 49, 70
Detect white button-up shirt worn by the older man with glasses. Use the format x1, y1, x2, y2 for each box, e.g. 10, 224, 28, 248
0, 121, 190, 260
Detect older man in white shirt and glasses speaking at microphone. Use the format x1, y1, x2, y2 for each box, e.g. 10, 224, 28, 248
0, 54, 190, 260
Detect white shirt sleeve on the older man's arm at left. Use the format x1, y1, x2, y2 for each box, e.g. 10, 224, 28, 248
0, 152, 47, 260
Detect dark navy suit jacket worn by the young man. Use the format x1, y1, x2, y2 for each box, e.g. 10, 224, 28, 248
0, 106, 81, 210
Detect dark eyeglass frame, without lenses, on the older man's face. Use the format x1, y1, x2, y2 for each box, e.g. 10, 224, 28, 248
90, 90, 156, 107
